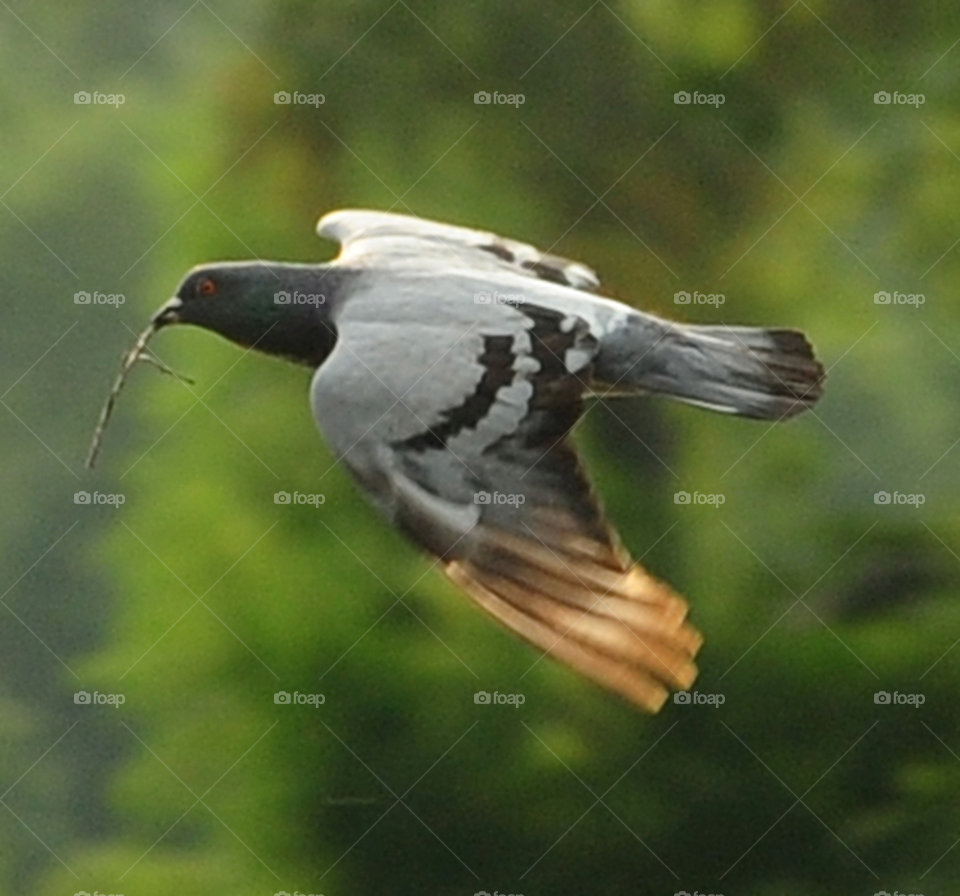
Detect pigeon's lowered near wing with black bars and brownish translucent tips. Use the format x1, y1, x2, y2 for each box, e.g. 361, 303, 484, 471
312, 296, 701, 711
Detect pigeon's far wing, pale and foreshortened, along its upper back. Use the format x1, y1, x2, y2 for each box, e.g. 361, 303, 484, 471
317, 209, 600, 292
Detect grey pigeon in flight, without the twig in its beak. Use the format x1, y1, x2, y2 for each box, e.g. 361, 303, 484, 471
138, 209, 825, 712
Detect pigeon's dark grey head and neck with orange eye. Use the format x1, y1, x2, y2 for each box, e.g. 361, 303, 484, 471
154, 262, 339, 367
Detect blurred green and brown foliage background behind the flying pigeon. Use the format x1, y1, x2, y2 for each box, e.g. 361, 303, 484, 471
0, 0, 960, 896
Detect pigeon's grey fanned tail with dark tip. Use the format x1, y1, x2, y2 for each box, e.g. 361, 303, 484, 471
595, 315, 824, 420
